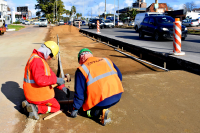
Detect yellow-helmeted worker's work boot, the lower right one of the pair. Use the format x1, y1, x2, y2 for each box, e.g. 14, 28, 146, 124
26, 104, 39, 120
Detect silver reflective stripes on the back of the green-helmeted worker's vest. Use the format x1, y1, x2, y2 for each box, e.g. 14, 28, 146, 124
82, 58, 117, 86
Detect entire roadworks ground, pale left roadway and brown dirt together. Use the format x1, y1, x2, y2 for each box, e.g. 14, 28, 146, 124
0, 25, 200, 133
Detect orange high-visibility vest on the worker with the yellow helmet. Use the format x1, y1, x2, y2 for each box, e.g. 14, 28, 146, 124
23, 54, 55, 102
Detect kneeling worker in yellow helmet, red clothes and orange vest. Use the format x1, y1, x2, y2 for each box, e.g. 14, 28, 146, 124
22, 41, 69, 120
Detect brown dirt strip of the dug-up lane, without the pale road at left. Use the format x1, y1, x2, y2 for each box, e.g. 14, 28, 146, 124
20, 25, 200, 133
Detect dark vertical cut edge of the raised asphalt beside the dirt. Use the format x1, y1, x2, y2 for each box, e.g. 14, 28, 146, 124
79, 29, 200, 74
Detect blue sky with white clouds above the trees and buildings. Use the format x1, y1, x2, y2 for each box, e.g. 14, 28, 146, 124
7, 0, 200, 17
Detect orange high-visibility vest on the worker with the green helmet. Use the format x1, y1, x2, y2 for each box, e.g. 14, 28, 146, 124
79, 57, 124, 111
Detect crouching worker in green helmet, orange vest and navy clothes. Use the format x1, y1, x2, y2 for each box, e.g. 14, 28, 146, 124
71, 48, 124, 126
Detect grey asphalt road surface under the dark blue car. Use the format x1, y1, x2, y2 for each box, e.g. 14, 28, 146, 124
81, 26, 200, 64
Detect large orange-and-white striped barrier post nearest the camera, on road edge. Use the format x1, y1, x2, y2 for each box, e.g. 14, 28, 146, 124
173, 18, 185, 55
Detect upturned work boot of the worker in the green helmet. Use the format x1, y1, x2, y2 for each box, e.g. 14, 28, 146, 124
101, 109, 112, 126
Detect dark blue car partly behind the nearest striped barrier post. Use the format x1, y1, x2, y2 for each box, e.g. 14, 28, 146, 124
139, 16, 187, 41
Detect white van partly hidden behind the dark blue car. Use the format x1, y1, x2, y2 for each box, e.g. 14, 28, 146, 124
134, 12, 164, 32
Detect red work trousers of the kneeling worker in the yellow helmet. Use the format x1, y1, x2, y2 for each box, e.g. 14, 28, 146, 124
27, 98, 60, 114
